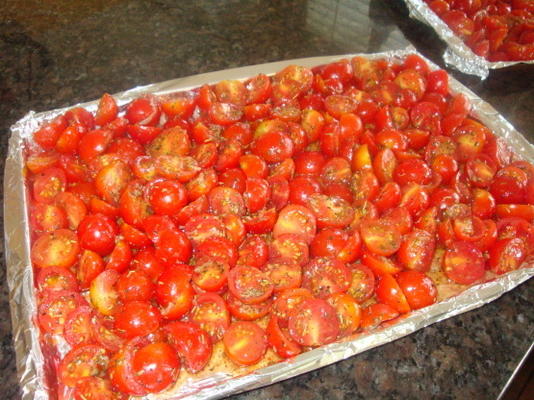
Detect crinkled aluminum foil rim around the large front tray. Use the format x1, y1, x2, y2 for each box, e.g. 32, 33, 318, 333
4, 46, 534, 400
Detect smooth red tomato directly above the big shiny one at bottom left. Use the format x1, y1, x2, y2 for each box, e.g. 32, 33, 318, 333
115, 300, 161, 339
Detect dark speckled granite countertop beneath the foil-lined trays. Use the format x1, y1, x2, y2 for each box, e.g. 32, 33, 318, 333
0, 0, 534, 400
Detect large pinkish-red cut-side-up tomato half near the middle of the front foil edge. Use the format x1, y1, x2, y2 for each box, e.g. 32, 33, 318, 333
288, 298, 339, 347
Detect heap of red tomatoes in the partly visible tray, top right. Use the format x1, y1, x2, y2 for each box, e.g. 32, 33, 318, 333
424, 0, 534, 61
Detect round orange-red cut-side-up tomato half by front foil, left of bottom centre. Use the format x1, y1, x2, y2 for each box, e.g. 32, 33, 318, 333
223, 321, 267, 365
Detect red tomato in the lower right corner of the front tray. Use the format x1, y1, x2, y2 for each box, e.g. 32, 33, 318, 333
488, 238, 528, 275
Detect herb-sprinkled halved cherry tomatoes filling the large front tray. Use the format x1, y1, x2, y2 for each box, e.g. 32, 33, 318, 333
26, 55, 534, 400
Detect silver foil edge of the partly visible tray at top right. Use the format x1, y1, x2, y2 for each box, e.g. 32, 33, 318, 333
405, 0, 534, 79
